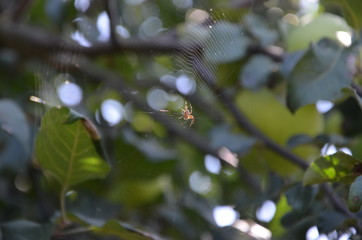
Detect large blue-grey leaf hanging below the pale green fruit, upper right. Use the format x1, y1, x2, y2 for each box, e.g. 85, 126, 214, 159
287, 39, 352, 112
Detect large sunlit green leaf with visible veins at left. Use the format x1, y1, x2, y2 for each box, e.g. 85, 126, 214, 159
35, 108, 110, 189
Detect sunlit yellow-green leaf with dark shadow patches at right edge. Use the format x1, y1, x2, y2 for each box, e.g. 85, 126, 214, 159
303, 152, 362, 185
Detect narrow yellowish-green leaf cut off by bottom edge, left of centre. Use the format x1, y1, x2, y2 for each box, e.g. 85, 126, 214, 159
94, 220, 159, 240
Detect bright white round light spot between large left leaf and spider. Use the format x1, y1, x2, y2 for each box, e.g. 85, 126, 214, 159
101, 99, 124, 126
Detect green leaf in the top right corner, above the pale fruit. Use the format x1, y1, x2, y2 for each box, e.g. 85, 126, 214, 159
322, 0, 362, 31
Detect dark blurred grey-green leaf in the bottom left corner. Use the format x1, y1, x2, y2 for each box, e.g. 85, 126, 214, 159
0, 220, 53, 240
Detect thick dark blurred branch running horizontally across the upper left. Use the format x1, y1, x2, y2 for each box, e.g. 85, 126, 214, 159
0, 21, 187, 57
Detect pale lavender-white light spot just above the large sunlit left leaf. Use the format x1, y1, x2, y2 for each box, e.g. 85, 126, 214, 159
57, 81, 83, 107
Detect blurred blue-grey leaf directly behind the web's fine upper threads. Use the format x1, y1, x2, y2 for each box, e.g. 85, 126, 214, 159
204, 21, 250, 63
